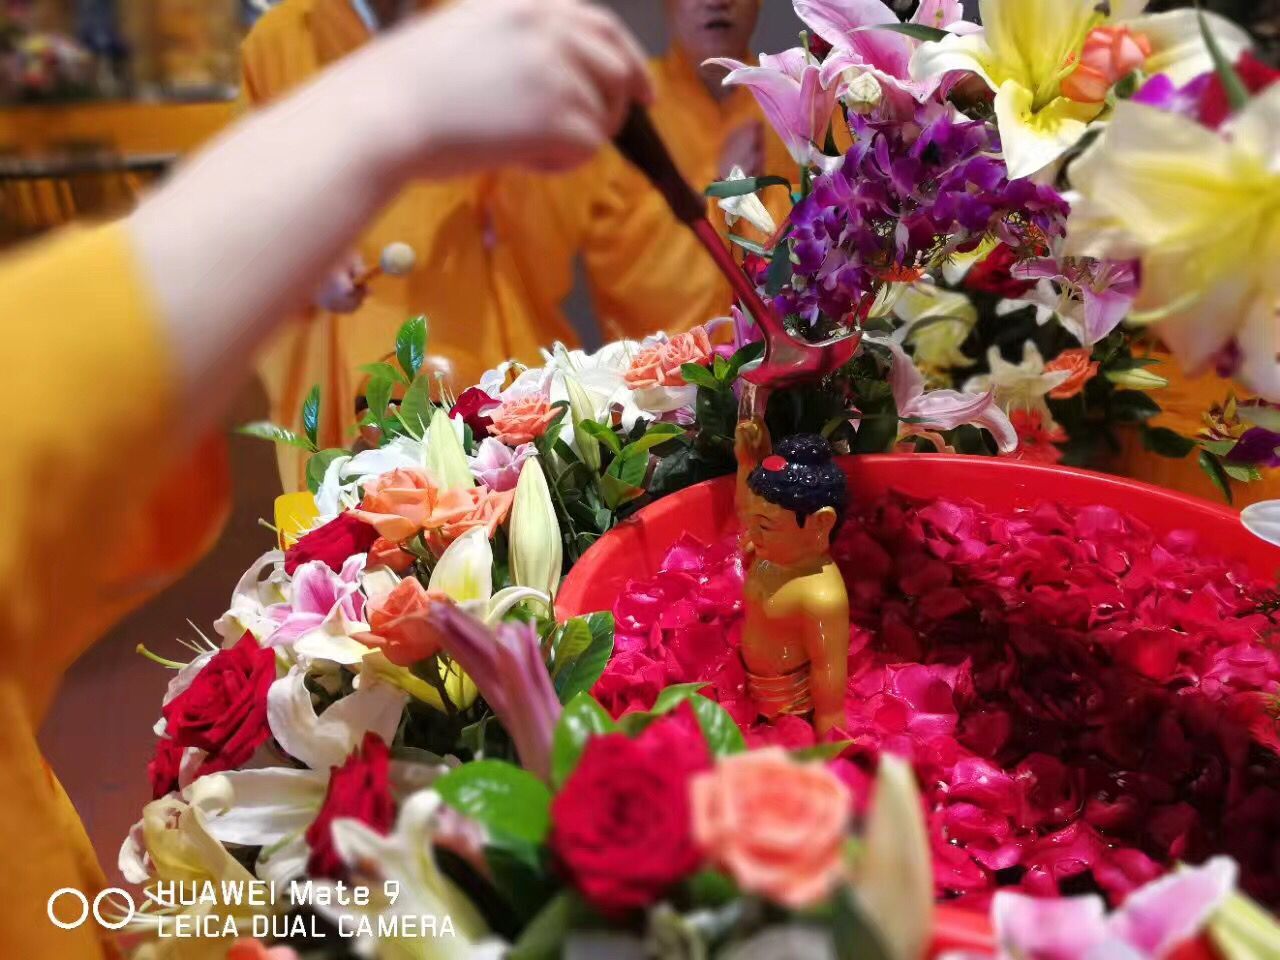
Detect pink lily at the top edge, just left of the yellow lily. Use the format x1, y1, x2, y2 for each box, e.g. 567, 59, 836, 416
795, 0, 975, 109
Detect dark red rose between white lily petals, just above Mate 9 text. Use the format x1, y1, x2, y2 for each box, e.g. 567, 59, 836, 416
307, 732, 396, 879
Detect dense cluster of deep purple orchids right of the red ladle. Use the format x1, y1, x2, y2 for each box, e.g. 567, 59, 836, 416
774, 104, 1069, 325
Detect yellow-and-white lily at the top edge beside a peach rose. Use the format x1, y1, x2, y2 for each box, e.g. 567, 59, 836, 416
911, 0, 1248, 179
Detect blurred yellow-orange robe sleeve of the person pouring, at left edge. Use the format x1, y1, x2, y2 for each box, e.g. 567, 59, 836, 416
0, 227, 228, 960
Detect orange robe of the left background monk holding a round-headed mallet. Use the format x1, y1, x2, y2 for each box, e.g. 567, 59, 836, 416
243, 0, 573, 486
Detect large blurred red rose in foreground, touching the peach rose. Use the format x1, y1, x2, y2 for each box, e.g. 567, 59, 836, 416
550, 705, 710, 915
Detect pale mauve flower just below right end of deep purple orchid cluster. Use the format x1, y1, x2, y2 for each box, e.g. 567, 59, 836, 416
1010, 257, 1138, 347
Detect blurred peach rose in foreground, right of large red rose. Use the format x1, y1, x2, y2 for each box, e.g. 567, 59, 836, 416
690, 748, 851, 909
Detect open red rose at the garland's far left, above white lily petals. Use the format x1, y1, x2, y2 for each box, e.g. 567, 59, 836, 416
164, 634, 275, 774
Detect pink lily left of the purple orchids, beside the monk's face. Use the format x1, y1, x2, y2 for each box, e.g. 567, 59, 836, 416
707, 47, 836, 166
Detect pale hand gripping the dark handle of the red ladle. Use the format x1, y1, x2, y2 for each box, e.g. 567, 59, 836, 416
361, 0, 653, 177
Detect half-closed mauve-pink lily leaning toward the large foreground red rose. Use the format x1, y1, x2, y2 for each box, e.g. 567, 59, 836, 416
428, 603, 561, 780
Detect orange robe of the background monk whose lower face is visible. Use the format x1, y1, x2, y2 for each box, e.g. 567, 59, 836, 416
498, 49, 797, 340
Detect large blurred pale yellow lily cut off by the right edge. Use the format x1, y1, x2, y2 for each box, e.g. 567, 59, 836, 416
1068, 87, 1280, 401
